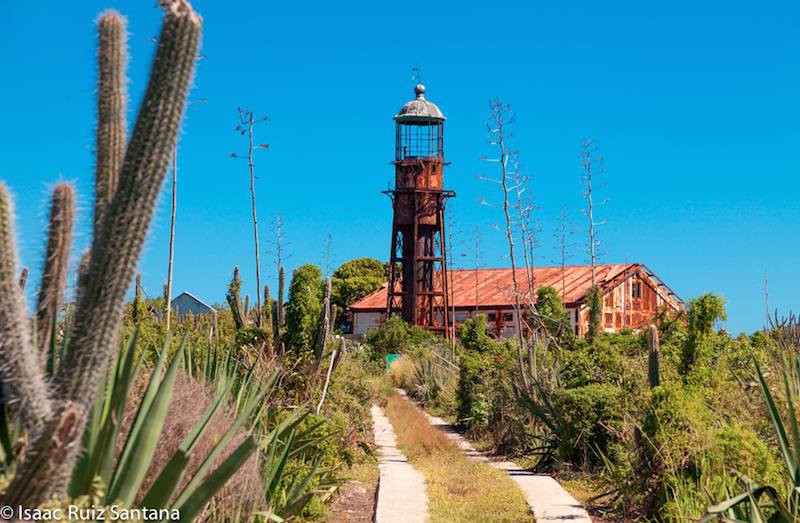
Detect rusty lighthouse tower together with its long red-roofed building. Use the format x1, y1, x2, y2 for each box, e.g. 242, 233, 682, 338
349, 84, 684, 338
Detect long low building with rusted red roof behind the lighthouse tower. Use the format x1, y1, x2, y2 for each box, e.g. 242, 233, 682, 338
349, 263, 685, 338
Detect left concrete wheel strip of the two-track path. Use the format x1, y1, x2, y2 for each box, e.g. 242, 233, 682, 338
372, 405, 428, 523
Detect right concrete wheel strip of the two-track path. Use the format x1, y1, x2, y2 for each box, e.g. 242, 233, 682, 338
416, 394, 592, 523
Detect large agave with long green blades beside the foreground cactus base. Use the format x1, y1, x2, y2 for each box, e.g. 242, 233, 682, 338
60, 334, 266, 520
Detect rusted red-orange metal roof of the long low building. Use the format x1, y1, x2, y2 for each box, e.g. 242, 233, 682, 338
350, 263, 683, 311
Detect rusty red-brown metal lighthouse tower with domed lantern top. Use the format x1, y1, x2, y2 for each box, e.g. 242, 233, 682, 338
384, 84, 455, 335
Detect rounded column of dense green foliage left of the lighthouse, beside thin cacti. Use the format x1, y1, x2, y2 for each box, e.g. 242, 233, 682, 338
284, 264, 322, 353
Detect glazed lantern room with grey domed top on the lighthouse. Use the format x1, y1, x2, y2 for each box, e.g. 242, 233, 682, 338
394, 84, 445, 161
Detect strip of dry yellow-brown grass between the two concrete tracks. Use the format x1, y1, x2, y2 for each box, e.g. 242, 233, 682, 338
386, 395, 533, 523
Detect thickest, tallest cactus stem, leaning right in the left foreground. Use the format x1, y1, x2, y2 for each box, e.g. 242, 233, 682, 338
64, 0, 201, 401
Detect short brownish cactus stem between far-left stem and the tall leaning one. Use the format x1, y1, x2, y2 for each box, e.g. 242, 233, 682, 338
36, 183, 75, 353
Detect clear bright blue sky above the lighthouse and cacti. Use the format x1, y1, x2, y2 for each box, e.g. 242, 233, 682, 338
0, 0, 800, 332
